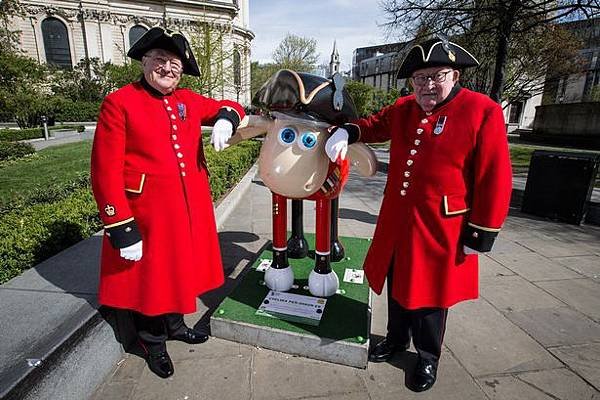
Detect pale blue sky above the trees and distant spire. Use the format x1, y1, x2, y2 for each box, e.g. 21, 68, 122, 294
249, 0, 394, 71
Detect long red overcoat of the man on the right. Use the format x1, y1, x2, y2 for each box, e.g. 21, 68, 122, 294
356, 88, 512, 309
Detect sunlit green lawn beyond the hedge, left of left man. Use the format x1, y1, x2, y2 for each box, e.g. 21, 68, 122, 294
0, 140, 92, 210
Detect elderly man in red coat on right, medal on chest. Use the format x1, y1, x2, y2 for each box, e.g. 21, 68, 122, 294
326, 38, 511, 391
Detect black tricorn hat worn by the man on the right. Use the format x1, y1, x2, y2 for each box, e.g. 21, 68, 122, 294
398, 37, 479, 78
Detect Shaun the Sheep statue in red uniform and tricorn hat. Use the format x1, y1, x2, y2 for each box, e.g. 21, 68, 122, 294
228, 70, 377, 297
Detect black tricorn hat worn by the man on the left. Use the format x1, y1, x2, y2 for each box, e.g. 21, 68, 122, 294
127, 26, 200, 76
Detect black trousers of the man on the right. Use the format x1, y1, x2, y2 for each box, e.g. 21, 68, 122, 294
387, 265, 448, 364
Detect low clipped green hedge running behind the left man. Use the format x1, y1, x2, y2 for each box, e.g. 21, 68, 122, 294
0, 141, 260, 284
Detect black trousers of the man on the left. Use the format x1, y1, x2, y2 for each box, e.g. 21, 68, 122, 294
131, 311, 186, 353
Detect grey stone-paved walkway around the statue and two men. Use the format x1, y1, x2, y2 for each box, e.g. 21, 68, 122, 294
93, 153, 600, 400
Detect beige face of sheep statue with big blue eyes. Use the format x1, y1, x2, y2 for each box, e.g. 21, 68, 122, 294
259, 114, 329, 199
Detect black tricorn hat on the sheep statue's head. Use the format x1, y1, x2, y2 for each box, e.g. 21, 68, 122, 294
252, 69, 358, 125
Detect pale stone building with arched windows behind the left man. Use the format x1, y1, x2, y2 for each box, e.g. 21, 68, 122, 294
13, 0, 254, 105
